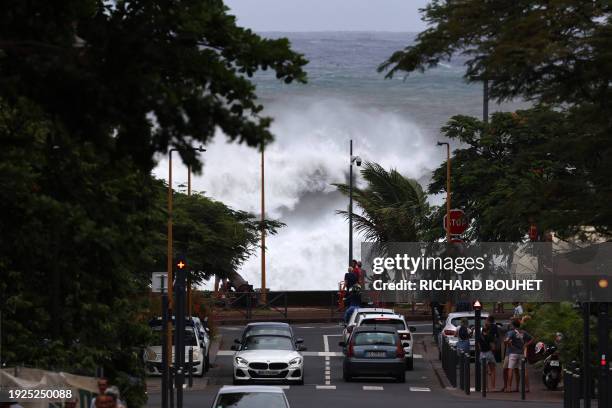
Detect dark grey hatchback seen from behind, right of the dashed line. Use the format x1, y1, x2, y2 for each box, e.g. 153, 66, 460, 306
338, 325, 406, 382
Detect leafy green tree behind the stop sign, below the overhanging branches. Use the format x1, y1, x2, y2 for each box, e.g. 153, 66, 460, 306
429, 108, 609, 242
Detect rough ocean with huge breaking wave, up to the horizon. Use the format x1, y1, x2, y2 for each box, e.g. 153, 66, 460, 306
155, 32, 522, 290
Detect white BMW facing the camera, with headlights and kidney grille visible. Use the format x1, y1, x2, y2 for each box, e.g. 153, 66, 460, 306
232, 323, 306, 385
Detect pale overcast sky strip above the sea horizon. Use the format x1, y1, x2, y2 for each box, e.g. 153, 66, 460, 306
225, 0, 428, 31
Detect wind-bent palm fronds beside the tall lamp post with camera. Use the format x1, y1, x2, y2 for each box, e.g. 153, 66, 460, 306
335, 163, 429, 242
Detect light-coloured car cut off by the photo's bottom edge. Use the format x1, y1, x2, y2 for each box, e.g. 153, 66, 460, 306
212, 385, 289, 408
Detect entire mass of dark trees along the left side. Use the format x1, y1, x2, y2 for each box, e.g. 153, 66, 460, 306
0, 0, 306, 407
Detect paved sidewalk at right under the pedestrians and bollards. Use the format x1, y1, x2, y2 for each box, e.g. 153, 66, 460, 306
421, 337, 563, 404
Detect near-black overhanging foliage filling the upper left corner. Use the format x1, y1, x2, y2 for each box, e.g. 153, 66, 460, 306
0, 0, 306, 171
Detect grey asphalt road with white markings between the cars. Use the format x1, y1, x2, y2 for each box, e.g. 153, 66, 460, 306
148, 322, 559, 408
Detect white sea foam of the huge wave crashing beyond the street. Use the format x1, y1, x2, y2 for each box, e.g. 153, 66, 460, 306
156, 96, 442, 289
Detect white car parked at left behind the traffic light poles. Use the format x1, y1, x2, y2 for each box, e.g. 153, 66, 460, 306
144, 319, 209, 377
